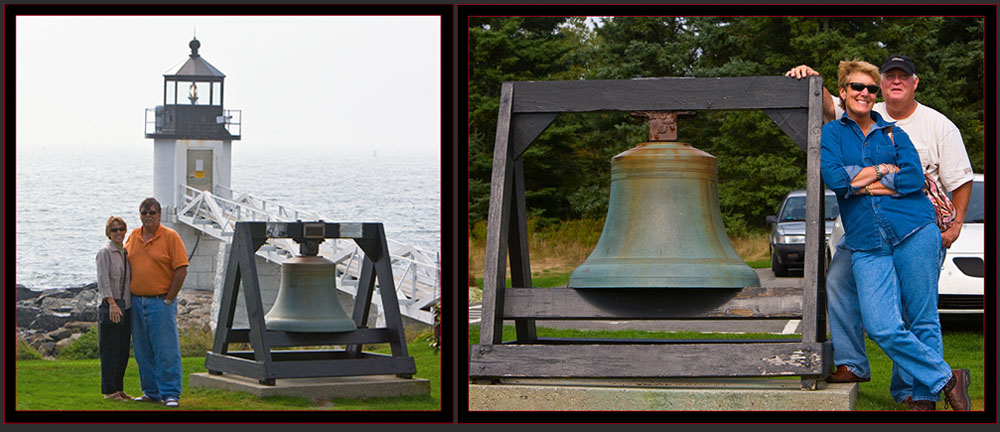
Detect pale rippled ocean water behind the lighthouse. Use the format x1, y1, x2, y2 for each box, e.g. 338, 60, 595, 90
14, 148, 441, 289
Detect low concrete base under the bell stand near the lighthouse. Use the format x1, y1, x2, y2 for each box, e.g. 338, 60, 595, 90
188, 372, 431, 399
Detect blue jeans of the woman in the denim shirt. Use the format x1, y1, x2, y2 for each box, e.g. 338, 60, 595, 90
851, 224, 952, 402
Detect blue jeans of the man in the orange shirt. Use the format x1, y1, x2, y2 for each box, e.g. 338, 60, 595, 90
132, 296, 181, 400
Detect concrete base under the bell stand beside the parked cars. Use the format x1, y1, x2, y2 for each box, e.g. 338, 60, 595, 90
469, 378, 858, 411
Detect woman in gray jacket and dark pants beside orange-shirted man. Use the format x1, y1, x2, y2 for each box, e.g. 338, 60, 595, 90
97, 216, 132, 400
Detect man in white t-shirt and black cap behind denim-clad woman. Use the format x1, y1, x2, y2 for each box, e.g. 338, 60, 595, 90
785, 54, 973, 410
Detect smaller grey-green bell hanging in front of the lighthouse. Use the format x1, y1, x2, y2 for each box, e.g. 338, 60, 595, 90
264, 248, 357, 333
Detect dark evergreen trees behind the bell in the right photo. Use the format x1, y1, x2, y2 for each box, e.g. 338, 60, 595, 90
470, 17, 984, 234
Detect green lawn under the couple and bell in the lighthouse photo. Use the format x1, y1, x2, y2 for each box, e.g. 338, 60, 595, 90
15, 338, 441, 411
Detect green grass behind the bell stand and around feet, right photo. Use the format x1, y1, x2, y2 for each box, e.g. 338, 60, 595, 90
469, 324, 984, 411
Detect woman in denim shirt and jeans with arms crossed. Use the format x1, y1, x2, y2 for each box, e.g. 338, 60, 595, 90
820, 60, 969, 410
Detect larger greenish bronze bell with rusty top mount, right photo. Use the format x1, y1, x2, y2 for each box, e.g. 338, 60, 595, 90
568, 112, 760, 288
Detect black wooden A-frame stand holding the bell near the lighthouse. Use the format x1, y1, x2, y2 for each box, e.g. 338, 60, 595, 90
205, 222, 417, 385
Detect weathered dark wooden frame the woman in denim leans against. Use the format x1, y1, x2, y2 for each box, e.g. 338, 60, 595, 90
469, 76, 832, 389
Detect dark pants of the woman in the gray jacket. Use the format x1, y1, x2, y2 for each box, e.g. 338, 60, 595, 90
97, 300, 132, 394
